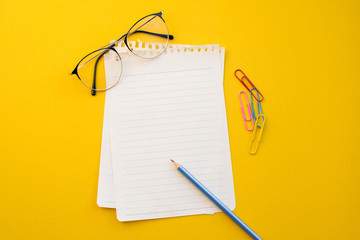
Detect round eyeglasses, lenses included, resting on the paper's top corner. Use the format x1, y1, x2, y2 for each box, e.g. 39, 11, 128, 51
70, 11, 174, 95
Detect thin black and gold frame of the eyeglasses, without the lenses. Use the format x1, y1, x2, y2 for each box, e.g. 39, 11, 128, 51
70, 11, 174, 96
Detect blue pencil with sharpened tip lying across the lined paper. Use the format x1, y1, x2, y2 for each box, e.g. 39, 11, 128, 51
171, 159, 262, 240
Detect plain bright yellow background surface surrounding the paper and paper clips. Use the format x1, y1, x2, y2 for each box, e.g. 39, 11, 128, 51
0, 0, 360, 240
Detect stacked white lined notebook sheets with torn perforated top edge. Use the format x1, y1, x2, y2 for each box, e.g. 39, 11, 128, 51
98, 42, 235, 221
